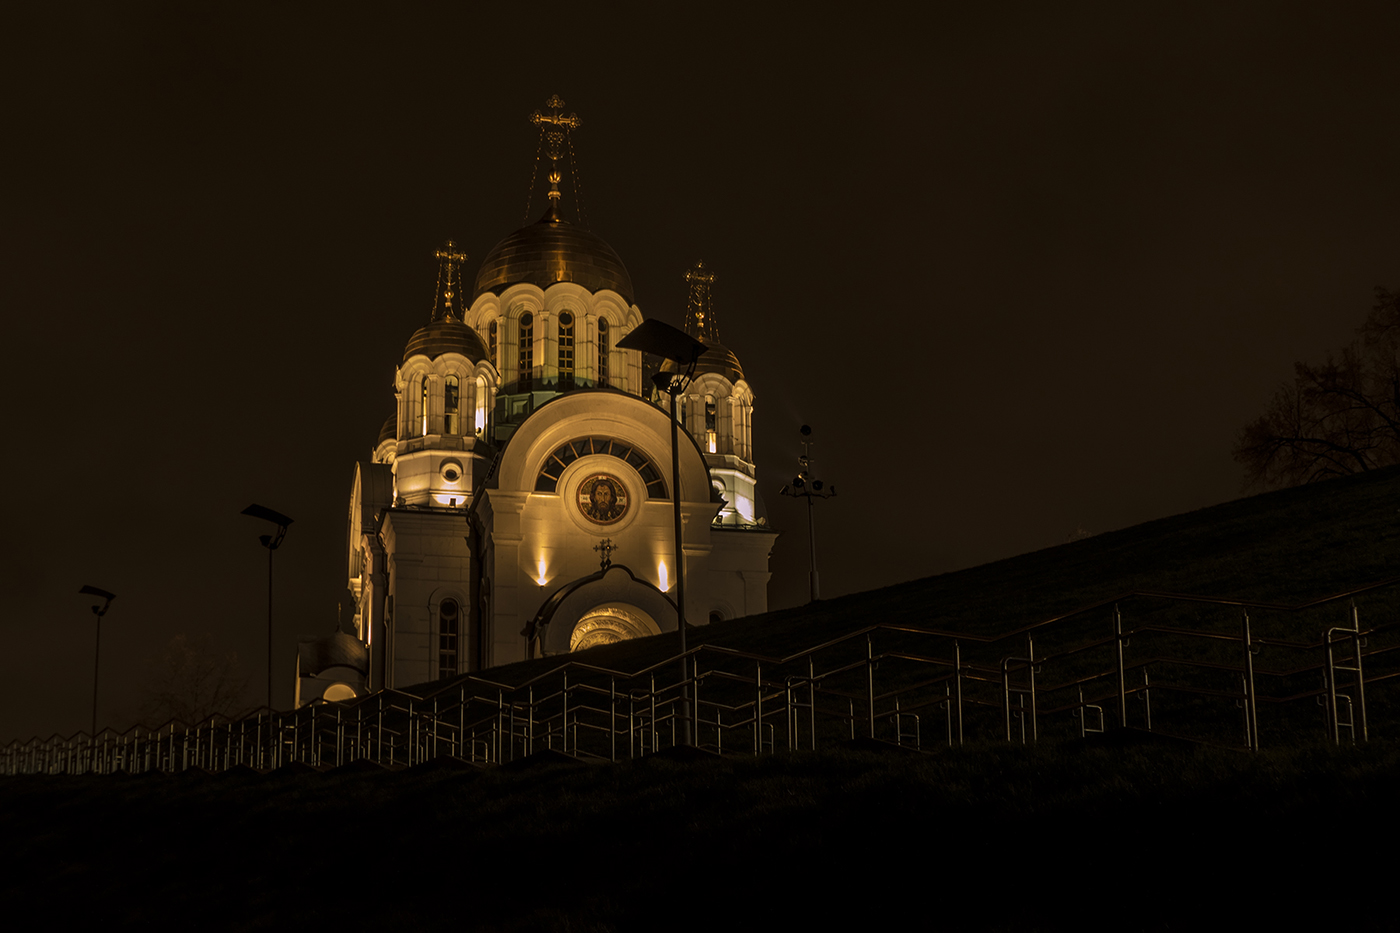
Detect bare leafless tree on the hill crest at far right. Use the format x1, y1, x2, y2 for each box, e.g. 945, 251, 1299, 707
1235, 287, 1400, 488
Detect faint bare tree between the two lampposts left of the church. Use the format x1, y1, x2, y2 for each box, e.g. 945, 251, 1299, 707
141, 633, 251, 726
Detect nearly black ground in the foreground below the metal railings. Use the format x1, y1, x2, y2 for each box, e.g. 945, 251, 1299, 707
0, 742, 1400, 932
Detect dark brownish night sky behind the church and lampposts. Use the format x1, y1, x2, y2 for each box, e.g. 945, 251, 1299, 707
0, 3, 1400, 740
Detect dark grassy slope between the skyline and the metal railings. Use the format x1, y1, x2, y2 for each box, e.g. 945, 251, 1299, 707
417, 468, 1400, 691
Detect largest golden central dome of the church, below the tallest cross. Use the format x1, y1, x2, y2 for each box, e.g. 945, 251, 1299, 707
472, 205, 633, 304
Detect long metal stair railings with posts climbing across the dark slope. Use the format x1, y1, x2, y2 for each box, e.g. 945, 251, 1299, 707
0, 579, 1400, 775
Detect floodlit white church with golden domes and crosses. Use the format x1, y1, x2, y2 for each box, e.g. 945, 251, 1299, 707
297, 97, 777, 706
